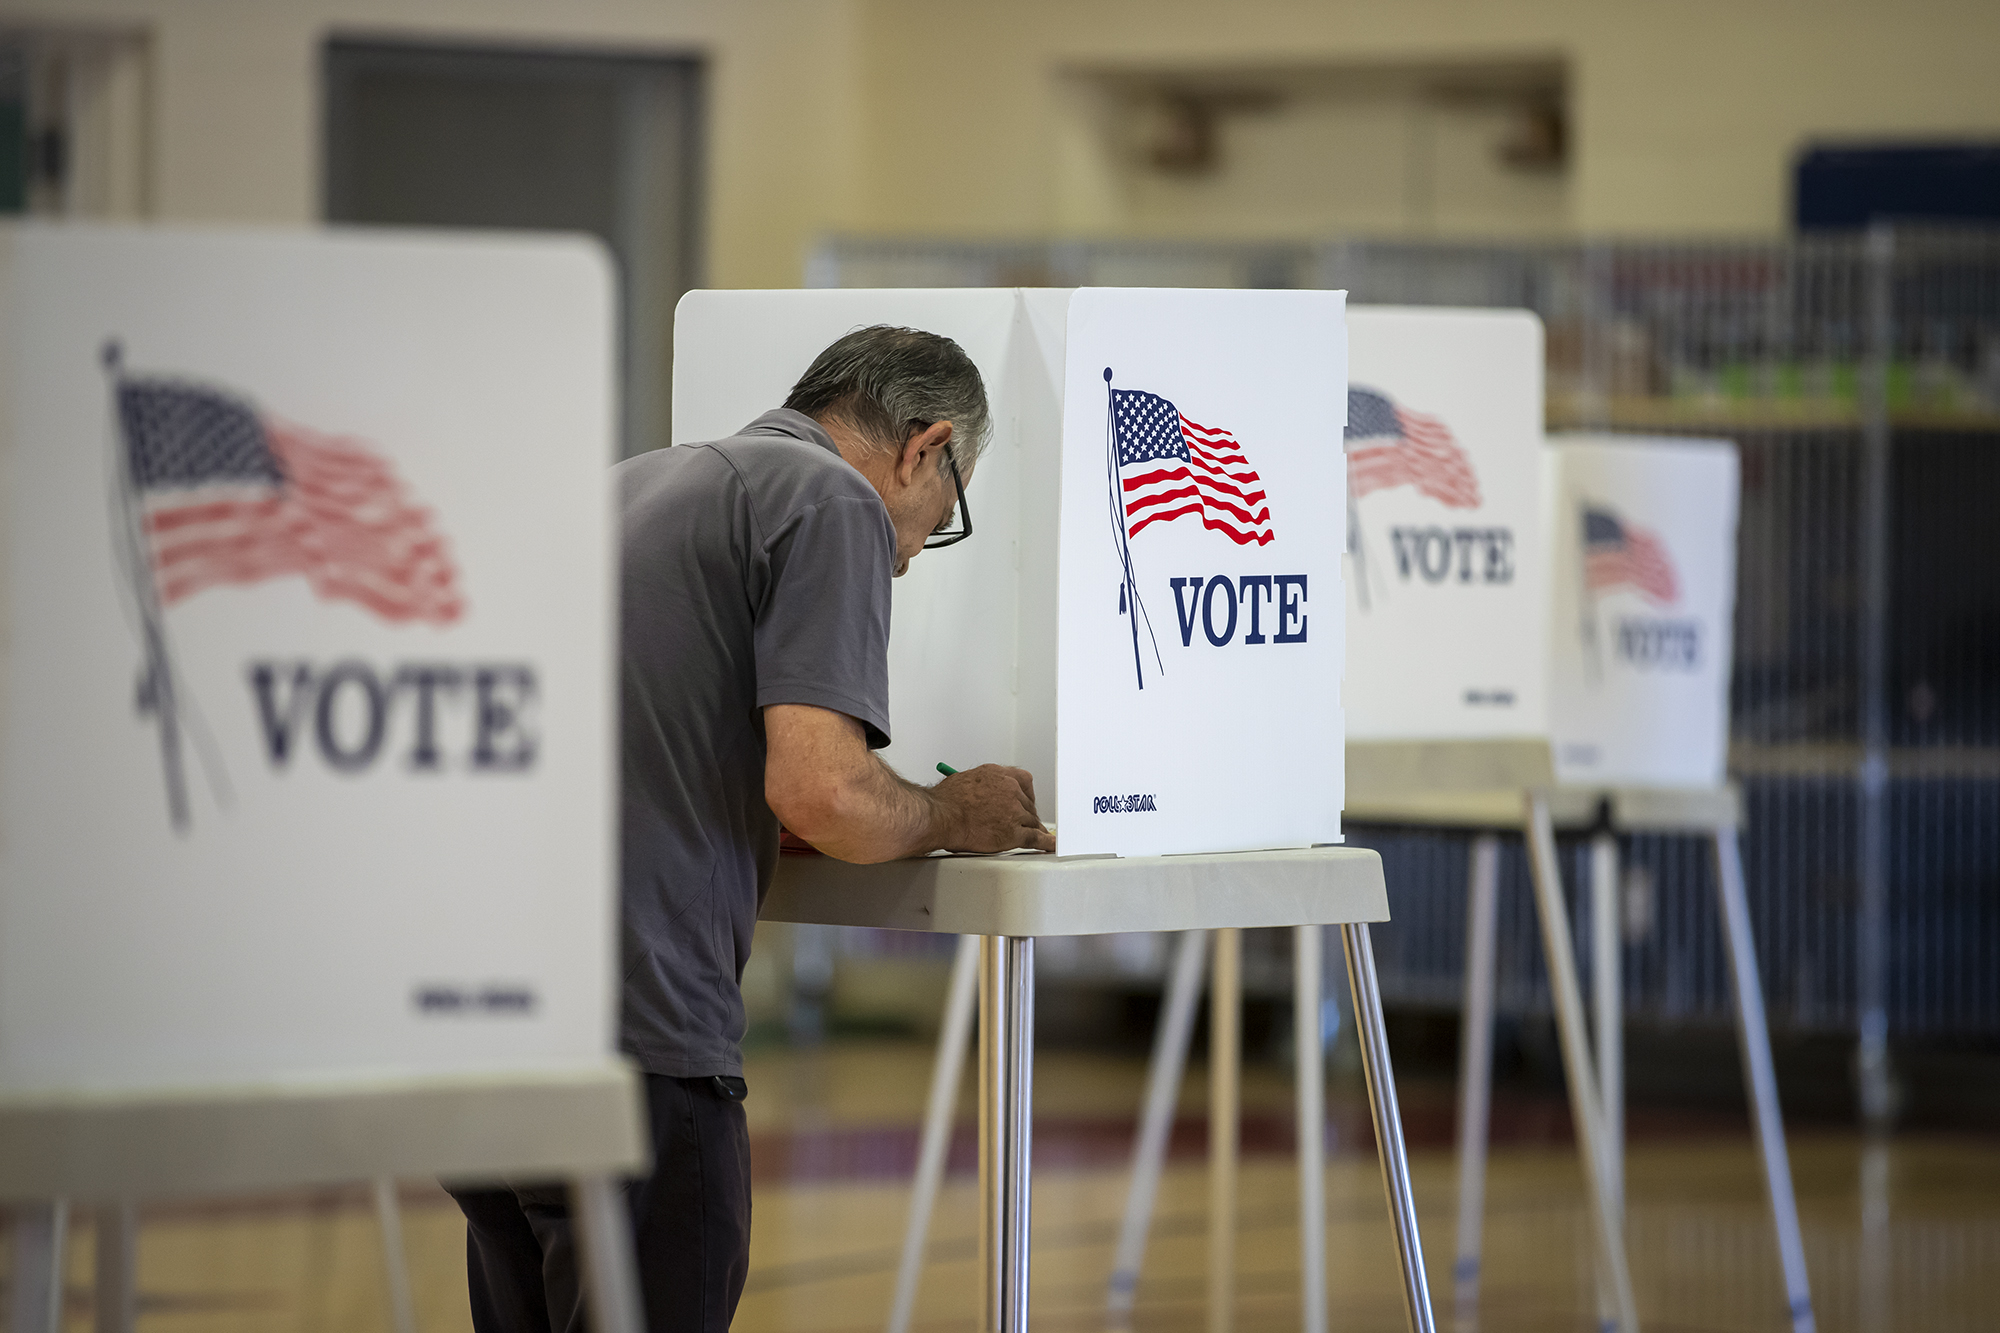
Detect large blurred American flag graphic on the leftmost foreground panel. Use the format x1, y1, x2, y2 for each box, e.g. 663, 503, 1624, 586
116, 376, 464, 624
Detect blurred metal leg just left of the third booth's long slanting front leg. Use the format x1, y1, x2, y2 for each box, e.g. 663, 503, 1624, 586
1452, 833, 1500, 1333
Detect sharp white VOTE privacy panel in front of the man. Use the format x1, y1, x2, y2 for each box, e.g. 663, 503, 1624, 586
674, 288, 1346, 855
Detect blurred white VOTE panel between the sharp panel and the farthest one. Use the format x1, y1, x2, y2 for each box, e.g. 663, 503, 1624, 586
1346, 306, 1548, 772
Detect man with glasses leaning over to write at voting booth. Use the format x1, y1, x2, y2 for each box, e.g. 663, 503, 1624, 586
454, 326, 1054, 1333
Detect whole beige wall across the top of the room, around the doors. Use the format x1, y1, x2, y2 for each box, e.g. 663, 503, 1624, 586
0, 0, 2000, 286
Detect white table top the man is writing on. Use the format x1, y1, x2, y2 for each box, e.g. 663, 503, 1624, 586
762, 847, 1388, 937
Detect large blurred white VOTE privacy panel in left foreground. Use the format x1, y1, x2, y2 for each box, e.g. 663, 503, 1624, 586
0, 228, 614, 1097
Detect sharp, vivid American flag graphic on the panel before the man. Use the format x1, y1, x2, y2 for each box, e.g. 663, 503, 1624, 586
1112, 388, 1272, 546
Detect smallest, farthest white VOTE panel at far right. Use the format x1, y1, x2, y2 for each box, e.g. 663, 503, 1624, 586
1546, 436, 1738, 791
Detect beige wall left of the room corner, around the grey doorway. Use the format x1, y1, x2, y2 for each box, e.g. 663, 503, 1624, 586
0, 0, 856, 286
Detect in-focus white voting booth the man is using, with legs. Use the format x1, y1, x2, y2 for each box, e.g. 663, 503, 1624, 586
674, 288, 1432, 1329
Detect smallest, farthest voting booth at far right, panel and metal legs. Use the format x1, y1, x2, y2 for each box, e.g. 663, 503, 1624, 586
1528, 434, 1814, 1333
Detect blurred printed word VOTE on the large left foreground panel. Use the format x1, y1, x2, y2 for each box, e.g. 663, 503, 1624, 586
248, 658, 538, 773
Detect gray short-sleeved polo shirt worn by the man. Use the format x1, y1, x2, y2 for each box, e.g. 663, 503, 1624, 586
614, 410, 896, 1079
